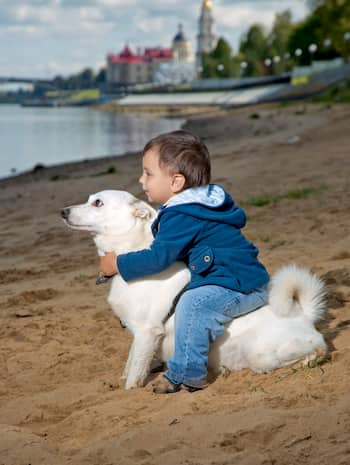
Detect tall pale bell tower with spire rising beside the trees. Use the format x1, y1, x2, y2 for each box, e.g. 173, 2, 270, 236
196, 0, 216, 68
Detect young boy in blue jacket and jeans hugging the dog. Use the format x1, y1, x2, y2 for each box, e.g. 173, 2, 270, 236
101, 131, 269, 394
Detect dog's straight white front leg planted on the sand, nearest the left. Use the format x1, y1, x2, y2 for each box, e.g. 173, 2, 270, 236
125, 327, 164, 389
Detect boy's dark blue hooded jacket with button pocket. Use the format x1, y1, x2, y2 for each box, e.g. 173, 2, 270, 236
117, 184, 269, 293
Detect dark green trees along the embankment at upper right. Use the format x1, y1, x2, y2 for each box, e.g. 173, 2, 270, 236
201, 0, 350, 78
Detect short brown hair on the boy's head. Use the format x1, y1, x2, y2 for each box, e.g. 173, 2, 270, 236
142, 131, 211, 189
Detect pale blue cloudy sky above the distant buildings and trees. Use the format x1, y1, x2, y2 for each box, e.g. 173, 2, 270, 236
0, 0, 307, 78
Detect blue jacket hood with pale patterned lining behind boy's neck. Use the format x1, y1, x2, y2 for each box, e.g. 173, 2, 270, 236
161, 184, 246, 228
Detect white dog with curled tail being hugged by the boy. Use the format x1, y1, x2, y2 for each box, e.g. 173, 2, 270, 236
61, 190, 326, 389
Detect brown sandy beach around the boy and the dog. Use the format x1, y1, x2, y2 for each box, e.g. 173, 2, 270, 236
0, 104, 350, 465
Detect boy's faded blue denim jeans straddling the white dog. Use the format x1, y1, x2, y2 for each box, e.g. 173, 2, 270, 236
164, 285, 267, 388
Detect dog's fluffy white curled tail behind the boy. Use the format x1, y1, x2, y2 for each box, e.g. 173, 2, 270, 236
269, 265, 326, 323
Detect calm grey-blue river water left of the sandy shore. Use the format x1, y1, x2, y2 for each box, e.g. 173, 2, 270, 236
0, 105, 184, 178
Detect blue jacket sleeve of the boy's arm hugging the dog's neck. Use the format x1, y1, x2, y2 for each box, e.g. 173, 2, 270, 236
117, 213, 200, 281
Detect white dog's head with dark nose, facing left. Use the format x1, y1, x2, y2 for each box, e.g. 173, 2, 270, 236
61, 190, 156, 236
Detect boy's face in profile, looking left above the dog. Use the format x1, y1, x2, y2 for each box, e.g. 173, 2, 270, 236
139, 147, 184, 204
